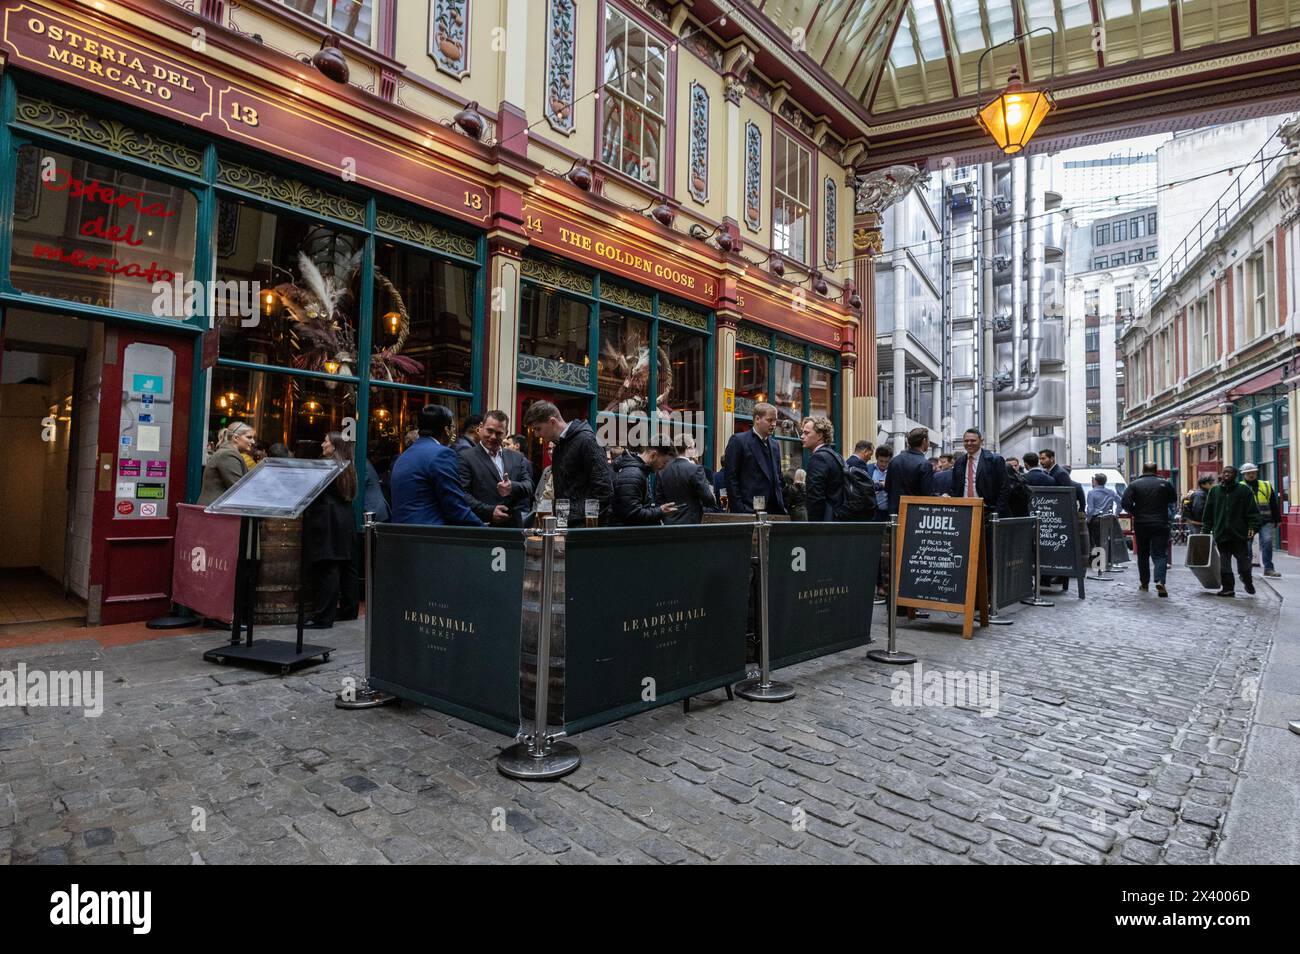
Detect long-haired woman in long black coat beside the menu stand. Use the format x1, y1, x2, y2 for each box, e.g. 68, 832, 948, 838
303, 430, 358, 629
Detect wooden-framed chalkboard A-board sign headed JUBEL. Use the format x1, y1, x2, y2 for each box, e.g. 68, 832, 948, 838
893, 496, 984, 637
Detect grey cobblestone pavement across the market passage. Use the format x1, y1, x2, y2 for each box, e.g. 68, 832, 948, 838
0, 569, 1279, 864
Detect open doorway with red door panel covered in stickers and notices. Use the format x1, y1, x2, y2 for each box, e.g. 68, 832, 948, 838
0, 309, 194, 632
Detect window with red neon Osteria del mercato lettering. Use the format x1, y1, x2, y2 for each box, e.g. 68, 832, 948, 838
9, 146, 196, 320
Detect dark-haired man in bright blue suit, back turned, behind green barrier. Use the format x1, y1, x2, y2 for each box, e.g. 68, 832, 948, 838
391, 404, 484, 526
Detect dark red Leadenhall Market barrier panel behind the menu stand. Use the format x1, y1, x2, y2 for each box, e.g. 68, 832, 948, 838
172, 503, 239, 623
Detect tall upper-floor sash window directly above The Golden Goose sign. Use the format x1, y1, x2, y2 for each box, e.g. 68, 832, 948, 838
601, 5, 668, 188
